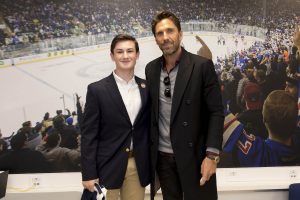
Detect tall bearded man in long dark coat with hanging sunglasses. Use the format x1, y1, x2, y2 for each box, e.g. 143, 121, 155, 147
146, 11, 224, 200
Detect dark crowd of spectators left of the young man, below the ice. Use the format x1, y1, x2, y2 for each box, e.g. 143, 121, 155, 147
0, 96, 82, 173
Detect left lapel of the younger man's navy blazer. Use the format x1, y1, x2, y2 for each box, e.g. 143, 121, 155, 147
103, 74, 131, 123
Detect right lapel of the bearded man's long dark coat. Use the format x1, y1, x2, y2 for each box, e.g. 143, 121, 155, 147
170, 48, 194, 124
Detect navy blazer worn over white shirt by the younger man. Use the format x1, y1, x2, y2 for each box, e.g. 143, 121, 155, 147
81, 74, 150, 189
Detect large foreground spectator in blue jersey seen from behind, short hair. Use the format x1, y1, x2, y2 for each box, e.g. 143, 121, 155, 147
224, 90, 300, 167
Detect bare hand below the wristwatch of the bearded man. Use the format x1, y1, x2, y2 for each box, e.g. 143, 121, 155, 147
200, 157, 217, 186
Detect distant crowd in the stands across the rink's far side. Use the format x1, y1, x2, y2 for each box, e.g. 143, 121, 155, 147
0, 0, 298, 45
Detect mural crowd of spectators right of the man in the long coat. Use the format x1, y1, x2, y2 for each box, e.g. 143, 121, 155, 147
217, 23, 300, 167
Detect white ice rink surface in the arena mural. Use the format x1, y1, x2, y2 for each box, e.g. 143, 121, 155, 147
0, 32, 259, 136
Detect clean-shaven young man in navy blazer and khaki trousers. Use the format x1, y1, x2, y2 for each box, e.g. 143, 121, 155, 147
81, 35, 150, 200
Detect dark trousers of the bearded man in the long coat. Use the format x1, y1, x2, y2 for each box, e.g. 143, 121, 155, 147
157, 152, 183, 200
